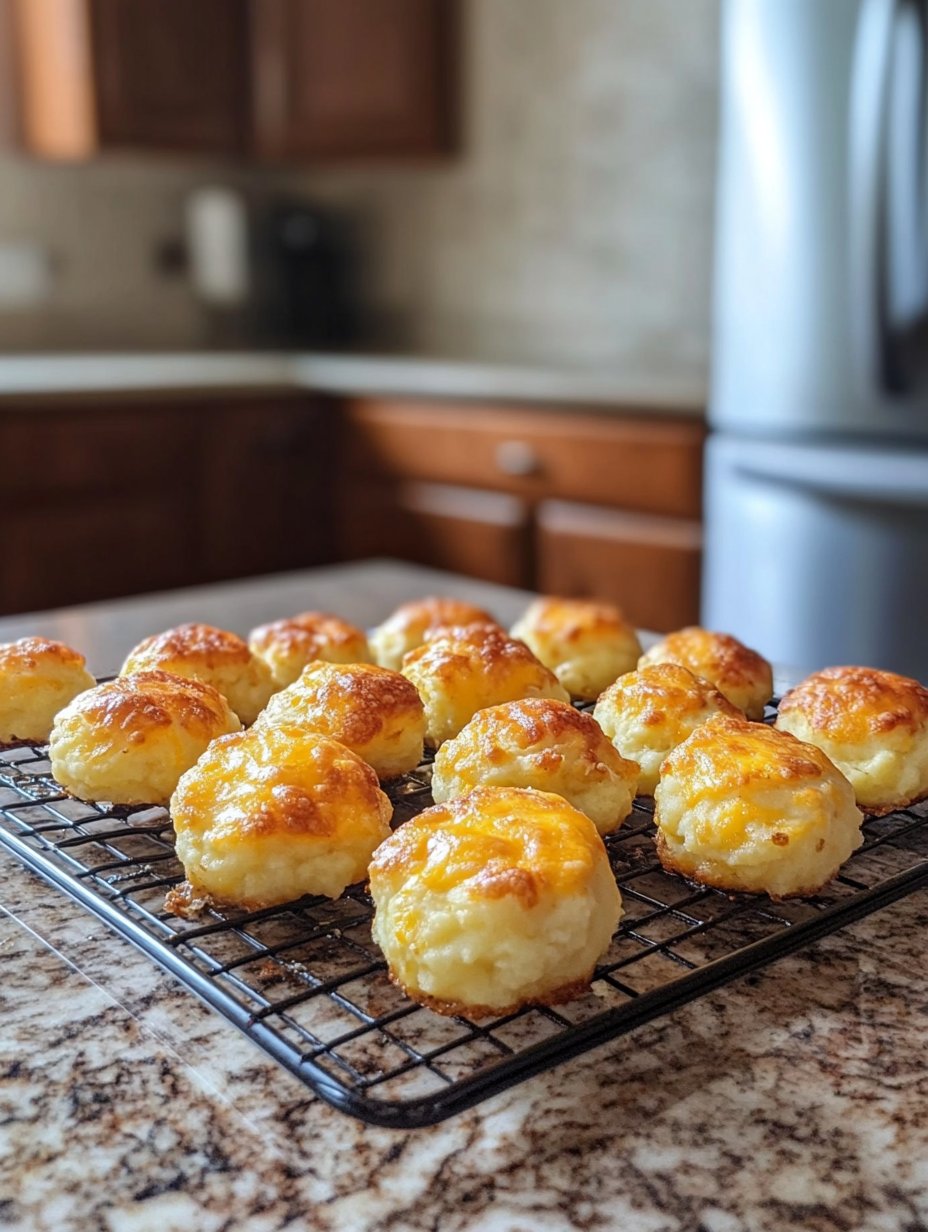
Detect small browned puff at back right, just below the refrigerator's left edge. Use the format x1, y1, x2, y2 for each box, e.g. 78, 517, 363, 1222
638, 626, 773, 719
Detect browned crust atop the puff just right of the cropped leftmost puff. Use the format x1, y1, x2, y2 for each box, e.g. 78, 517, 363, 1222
69, 669, 229, 743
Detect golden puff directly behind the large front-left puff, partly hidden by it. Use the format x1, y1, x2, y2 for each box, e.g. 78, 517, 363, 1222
258, 663, 425, 779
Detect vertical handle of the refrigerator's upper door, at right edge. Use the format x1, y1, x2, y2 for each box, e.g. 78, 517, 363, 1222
848, 0, 928, 398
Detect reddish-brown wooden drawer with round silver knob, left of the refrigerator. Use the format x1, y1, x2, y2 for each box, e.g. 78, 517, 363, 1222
346, 398, 705, 517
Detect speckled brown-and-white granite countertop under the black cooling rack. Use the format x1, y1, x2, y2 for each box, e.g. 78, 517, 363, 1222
0, 562, 928, 1232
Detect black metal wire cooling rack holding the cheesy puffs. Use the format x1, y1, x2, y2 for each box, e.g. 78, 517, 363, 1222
0, 724, 928, 1129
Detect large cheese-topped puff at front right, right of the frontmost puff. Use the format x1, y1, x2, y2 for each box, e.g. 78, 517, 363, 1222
654, 717, 863, 898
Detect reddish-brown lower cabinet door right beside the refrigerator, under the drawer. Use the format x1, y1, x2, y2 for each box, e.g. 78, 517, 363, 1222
536, 500, 702, 632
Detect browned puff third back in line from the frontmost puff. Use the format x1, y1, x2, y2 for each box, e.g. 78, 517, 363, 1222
403, 628, 569, 748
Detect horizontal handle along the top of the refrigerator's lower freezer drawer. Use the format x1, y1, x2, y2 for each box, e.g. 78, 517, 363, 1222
730, 445, 928, 509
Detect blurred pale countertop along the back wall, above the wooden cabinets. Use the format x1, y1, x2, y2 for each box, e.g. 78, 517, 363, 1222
0, 351, 706, 416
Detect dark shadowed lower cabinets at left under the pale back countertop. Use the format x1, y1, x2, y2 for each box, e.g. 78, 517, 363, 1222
0, 394, 334, 614
